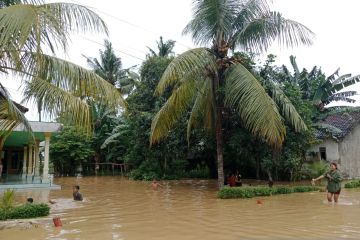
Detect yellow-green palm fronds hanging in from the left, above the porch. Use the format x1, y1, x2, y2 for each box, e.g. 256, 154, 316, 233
0, 0, 124, 138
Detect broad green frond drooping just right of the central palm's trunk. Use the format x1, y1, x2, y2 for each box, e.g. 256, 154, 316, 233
225, 64, 285, 147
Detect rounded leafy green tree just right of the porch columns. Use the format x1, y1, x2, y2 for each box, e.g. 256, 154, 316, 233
50, 127, 94, 175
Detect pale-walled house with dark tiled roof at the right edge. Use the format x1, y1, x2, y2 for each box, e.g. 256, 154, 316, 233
309, 112, 360, 178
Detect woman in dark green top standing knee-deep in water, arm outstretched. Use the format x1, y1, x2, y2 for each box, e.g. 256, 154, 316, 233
312, 163, 342, 203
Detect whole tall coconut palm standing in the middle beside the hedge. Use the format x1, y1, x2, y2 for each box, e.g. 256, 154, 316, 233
150, 0, 313, 188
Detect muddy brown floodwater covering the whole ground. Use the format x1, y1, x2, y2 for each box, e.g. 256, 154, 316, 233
0, 177, 360, 240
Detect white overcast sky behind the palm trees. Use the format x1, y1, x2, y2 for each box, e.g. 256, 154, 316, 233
2, 0, 360, 120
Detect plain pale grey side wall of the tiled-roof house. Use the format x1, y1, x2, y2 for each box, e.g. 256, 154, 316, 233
339, 125, 360, 178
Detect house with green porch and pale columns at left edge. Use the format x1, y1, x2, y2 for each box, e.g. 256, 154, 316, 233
0, 122, 61, 183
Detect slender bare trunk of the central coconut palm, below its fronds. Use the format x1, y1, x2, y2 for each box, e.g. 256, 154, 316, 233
216, 107, 224, 189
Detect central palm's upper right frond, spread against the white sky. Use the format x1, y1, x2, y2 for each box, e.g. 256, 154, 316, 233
230, 12, 314, 53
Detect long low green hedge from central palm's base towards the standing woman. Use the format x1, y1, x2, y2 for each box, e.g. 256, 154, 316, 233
218, 186, 321, 199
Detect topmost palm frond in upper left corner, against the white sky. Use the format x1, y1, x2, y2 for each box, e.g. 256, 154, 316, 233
0, 3, 108, 54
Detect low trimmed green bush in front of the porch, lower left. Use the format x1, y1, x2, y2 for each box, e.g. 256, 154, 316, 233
0, 203, 50, 220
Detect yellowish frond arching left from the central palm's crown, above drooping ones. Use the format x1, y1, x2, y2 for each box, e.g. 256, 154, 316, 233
155, 48, 217, 96
